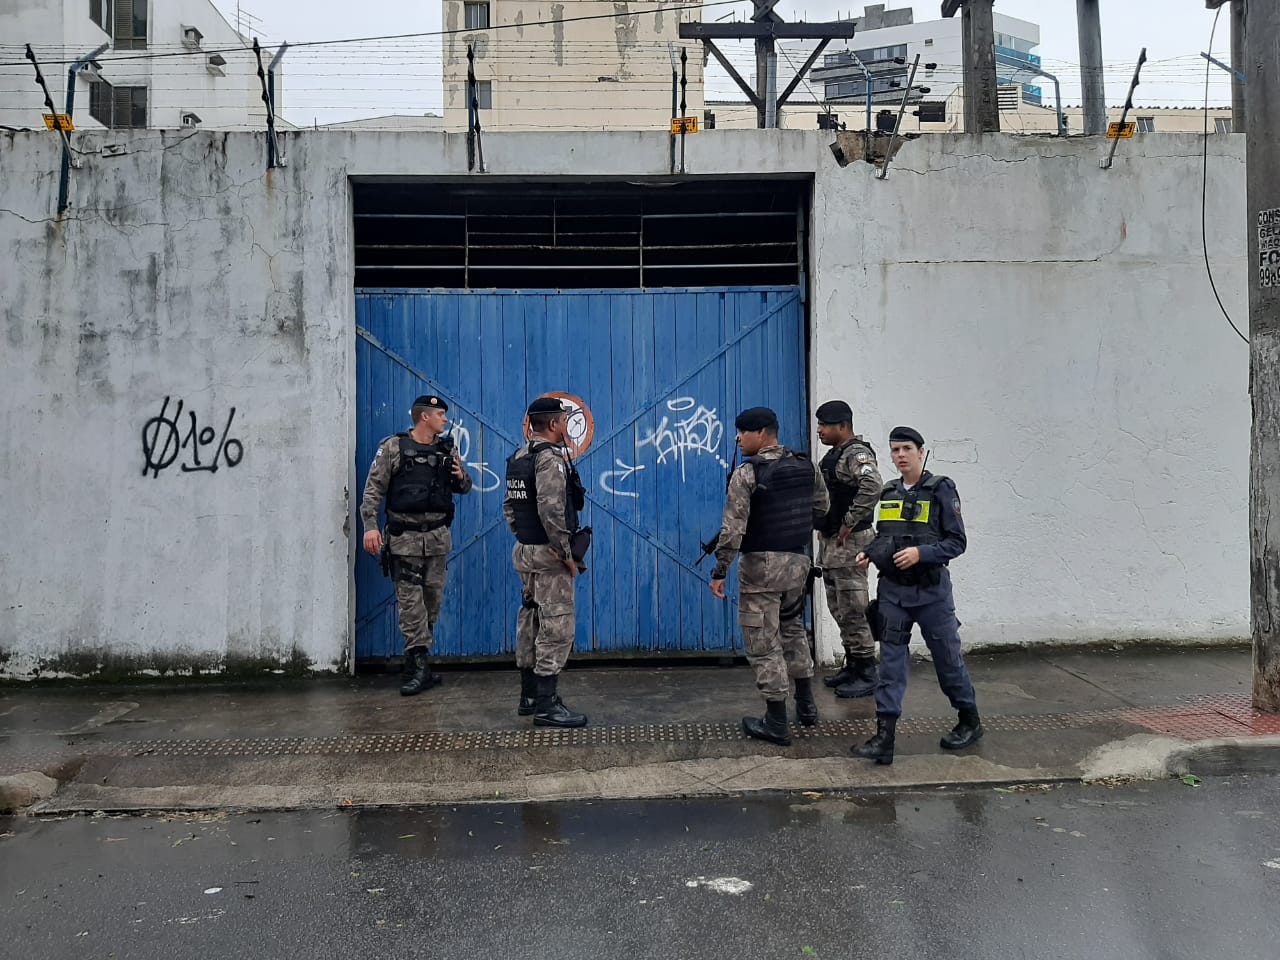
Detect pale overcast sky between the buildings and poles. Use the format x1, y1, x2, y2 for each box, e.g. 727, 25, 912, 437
214, 0, 1230, 125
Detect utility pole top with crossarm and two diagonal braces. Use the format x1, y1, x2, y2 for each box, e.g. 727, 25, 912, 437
680, 0, 855, 128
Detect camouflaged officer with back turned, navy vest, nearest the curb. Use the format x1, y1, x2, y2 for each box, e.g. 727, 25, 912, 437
710, 407, 831, 746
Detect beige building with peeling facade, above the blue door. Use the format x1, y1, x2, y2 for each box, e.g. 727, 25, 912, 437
443, 0, 703, 131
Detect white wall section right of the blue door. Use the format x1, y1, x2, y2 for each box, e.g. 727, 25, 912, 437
813, 136, 1249, 644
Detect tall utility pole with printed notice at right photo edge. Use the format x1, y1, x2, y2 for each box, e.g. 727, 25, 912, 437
1244, 1, 1280, 712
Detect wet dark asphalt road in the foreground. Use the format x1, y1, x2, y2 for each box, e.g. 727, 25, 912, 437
0, 777, 1280, 960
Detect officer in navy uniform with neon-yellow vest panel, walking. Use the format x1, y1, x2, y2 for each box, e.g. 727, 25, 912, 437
850, 426, 983, 764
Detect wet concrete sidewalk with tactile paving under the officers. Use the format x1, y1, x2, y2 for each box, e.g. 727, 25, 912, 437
0, 648, 1280, 813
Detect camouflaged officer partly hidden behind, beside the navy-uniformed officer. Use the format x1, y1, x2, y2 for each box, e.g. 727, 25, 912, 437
817, 401, 883, 698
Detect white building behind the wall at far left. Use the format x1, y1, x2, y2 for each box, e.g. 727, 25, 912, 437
0, 0, 282, 129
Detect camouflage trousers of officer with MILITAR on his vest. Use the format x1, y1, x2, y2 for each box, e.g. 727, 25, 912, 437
515, 545, 576, 677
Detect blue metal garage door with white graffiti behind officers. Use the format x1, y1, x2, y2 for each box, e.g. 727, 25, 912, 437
355, 287, 808, 658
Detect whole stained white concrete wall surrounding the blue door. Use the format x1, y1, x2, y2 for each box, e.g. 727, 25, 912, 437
0, 131, 1249, 677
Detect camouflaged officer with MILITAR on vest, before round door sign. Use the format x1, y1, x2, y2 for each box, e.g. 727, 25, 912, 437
502, 397, 586, 727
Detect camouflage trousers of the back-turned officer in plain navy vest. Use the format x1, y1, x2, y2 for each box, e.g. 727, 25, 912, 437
737, 554, 813, 700
